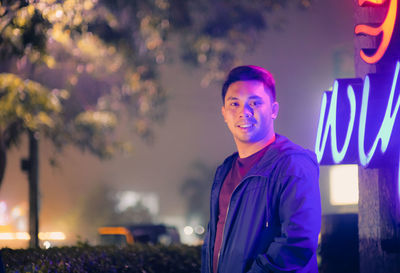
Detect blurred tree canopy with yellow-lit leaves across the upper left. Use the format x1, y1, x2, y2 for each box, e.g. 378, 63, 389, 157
0, 0, 310, 187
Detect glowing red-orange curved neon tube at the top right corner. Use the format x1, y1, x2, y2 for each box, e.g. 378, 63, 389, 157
354, 0, 397, 64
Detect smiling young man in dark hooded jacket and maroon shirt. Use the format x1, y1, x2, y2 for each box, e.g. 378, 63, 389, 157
202, 66, 321, 273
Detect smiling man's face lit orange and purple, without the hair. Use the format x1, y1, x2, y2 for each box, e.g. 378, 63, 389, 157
222, 81, 279, 145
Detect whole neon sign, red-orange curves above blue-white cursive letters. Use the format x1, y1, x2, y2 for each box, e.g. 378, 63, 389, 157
315, 0, 400, 208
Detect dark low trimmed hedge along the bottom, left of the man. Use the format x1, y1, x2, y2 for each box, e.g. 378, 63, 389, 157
1, 244, 201, 273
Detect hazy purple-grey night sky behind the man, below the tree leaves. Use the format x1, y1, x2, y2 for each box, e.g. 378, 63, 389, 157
0, 0, 354, 242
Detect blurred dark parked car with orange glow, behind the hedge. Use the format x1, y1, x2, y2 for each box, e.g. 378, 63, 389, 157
98, 224, 180, 246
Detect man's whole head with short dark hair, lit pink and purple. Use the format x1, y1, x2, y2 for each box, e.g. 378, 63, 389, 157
221, 66, 279, 157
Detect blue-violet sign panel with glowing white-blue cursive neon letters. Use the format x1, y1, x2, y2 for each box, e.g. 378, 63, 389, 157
315, 62, 400, 167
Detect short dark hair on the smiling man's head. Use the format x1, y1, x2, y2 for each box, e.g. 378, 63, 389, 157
222, 65, 276, 104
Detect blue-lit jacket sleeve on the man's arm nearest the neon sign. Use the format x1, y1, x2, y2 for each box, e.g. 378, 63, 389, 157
249, 156, 321, 273
